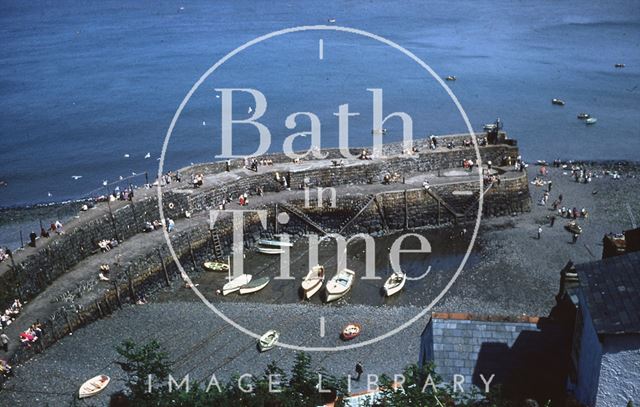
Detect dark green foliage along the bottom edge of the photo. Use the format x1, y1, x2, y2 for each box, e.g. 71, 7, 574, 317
112, 340, 548, 407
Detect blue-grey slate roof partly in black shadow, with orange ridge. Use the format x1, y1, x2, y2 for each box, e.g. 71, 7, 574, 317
421, 313, 571, 399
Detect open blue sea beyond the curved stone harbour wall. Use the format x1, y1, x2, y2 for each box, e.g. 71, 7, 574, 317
0, 0, 640, 247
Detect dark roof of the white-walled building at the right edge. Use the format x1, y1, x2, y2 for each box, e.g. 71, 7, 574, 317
576, 252, 640, 334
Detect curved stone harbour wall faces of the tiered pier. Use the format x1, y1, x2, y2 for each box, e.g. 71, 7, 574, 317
0, 136, 530, 362
